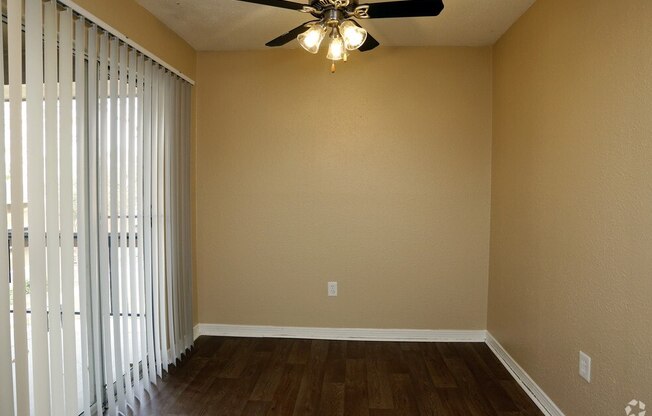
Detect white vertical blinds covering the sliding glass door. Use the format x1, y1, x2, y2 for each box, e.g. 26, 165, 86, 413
0, 0, 193, 416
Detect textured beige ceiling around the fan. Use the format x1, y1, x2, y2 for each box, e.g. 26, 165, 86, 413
137, 0, 534, 51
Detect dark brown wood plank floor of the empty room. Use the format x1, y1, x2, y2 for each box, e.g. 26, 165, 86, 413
131, 337, 542, 416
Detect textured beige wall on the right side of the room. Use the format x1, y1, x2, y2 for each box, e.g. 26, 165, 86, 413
488, 0, 652, 416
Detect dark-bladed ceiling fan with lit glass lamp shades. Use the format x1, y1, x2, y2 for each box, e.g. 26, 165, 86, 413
240, 0, 444, 72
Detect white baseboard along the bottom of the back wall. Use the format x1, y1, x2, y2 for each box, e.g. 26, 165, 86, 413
194, 324, 486, 342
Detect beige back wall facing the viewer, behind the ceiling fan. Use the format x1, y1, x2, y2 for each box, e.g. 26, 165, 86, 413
197, 48, 491, 329
